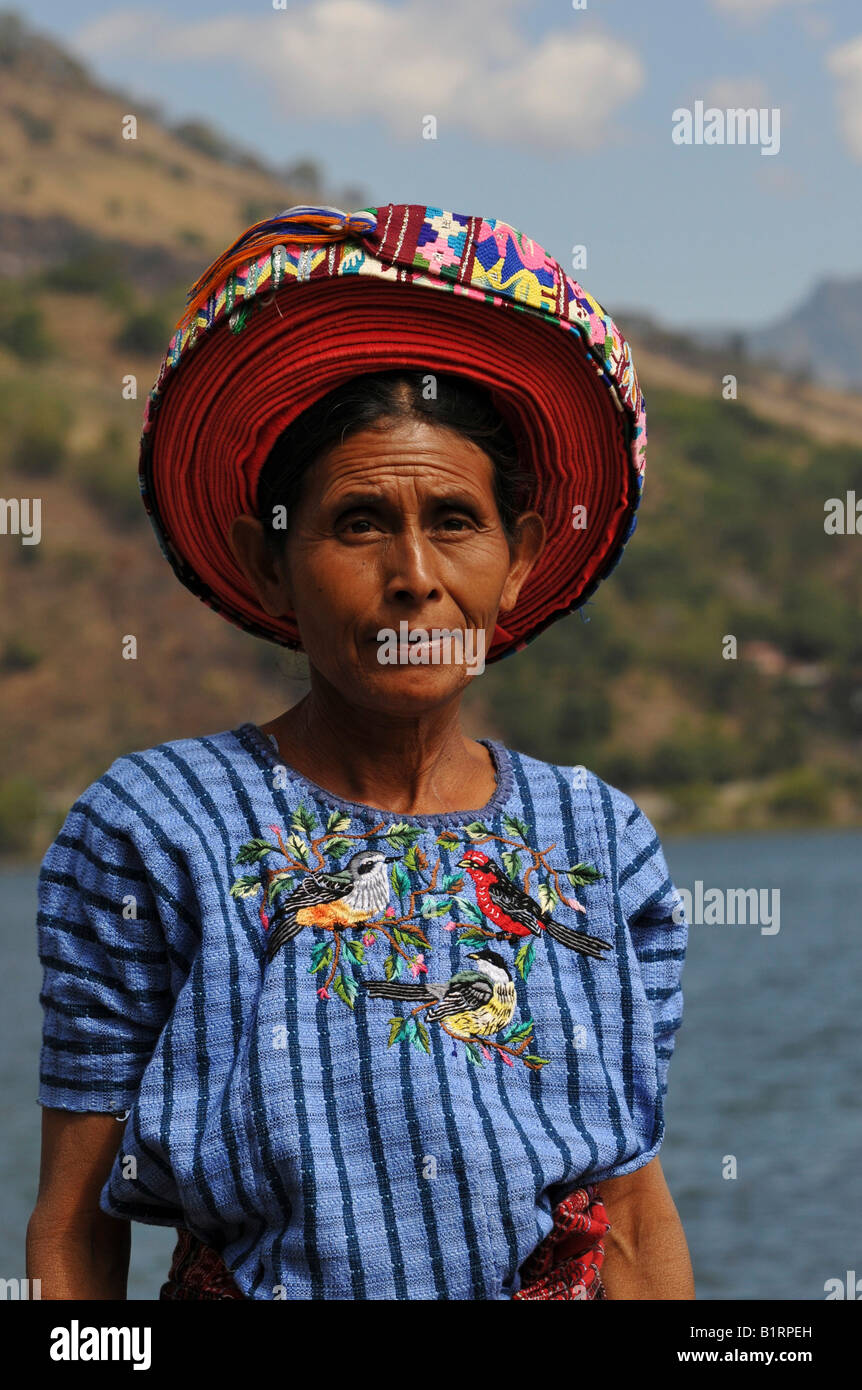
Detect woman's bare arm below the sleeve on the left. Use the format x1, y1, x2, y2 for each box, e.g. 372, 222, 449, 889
26, 1106, 132, 1300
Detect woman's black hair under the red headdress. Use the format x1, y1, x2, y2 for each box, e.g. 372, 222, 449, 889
256, 367, 535, 555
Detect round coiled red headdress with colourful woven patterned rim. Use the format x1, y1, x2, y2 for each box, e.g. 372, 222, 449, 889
139, 203, 647, 662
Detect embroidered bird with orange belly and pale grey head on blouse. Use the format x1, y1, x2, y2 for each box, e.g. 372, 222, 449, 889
267, 849, 400, 960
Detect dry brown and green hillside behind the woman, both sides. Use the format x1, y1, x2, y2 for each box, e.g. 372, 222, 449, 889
0, 17, 862, 859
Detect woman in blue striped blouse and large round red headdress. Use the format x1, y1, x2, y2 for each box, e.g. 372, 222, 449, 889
28, 204, 694, 1300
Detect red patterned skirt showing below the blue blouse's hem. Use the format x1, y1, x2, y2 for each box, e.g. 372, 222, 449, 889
158, 1186, 610, 1300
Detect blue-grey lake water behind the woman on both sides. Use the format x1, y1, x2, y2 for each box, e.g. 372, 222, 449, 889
0, 831, 862, 1300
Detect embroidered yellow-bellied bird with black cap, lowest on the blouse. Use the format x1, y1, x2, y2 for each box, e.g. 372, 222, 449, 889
363, 947, 516, 1038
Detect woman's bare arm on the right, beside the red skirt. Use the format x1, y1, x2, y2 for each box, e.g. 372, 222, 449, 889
596, 1155, 695, 1298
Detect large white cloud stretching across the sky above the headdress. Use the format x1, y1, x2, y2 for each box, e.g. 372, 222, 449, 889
76, 0, 645, 152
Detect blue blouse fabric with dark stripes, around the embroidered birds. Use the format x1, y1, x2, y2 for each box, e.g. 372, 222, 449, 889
38, 724, 687, 1300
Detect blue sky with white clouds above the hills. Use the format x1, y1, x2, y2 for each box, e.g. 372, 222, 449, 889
20, 0, 862, 329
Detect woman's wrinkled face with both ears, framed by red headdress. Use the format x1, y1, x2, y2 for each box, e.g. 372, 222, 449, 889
234, 420, 545, 714
